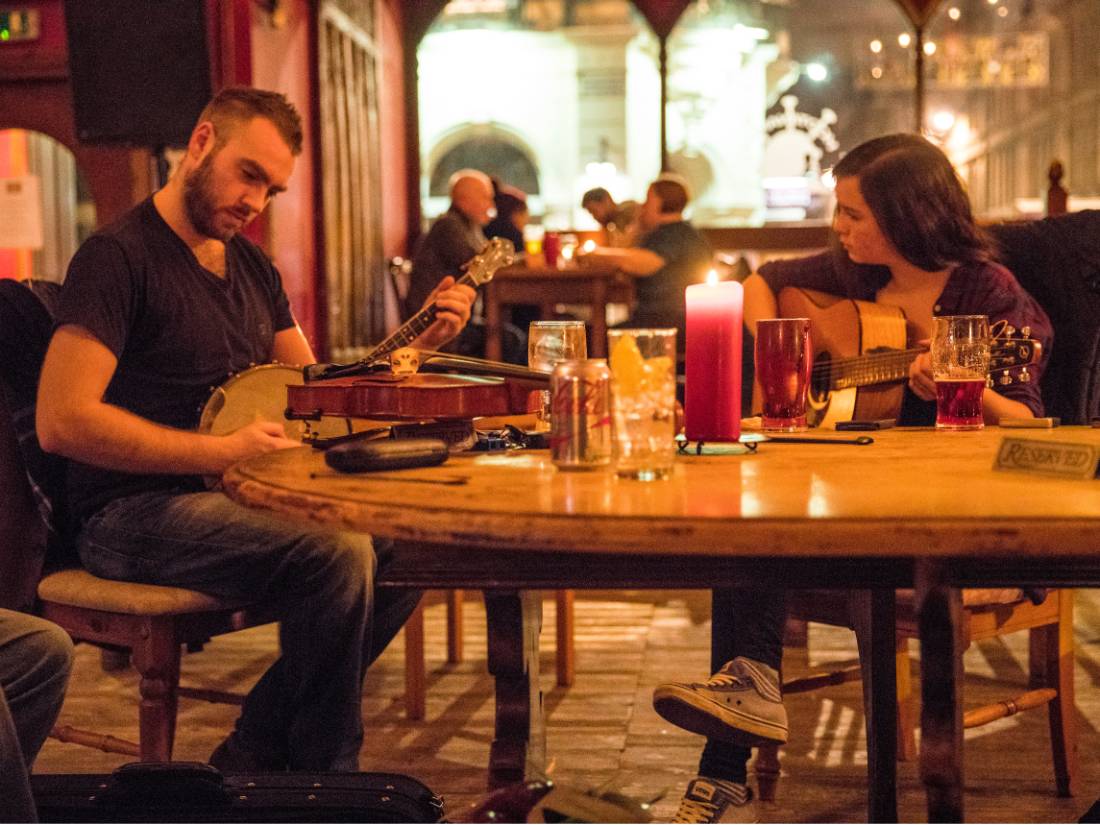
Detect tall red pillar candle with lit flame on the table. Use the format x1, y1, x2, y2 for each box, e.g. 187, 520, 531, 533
684, 281, 745, 441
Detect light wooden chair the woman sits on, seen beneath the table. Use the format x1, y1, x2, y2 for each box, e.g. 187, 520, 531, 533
754, 589, 1080, 801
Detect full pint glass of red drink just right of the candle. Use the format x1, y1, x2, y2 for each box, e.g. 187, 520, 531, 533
756, 318, 814, 432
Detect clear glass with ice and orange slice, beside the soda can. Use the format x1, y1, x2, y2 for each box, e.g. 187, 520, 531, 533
607, 329, 677, 481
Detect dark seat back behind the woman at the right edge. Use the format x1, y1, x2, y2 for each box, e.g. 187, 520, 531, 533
990, 210, 1100, 424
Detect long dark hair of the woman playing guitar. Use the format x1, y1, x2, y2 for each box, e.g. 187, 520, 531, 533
833, 134, 993, 272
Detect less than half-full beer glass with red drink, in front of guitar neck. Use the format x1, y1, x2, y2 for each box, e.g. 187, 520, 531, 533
932, 315, 990, 430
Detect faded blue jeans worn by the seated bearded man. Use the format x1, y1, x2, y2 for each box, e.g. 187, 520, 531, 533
77, 492, 419, 771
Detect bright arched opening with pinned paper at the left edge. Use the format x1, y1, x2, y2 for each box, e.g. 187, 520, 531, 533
0, 129, 96, 282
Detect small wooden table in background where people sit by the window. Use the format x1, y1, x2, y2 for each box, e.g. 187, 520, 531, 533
485, 263, 634, 361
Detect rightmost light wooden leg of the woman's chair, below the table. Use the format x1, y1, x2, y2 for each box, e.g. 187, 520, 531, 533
1030, 590, 1080, 796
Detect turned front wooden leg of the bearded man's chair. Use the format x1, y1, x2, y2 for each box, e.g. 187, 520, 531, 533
133, 618, 180, 762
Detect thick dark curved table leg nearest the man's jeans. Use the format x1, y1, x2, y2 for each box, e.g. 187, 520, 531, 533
485, 591, 547, 789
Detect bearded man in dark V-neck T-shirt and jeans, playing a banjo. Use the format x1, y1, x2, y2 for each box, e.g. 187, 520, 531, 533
36, 89, 473, 772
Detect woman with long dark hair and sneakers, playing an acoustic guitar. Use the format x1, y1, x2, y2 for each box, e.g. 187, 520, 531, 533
653, 134, 1052, 822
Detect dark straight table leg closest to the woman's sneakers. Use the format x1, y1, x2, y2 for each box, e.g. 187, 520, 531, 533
851, 587, 898, 822
